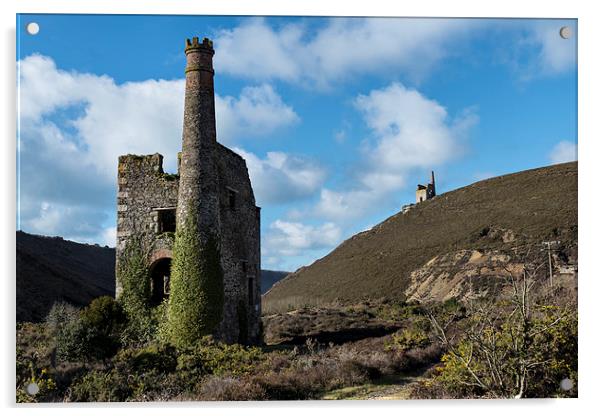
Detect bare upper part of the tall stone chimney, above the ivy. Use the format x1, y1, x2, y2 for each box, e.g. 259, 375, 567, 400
177, 37, 219, 236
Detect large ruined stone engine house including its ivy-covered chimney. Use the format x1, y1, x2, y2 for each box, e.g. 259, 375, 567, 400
116, 37, 261, 343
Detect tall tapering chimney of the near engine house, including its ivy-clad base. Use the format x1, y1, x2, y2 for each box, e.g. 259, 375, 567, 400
167, 37, 224, 346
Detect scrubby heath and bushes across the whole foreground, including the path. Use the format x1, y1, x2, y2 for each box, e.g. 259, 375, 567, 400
16, 270, 577, 402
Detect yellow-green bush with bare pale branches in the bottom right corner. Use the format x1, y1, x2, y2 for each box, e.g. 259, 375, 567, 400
428, 296, 577, 398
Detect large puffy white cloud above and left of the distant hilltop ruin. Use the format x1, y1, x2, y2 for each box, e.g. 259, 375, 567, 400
314, 83, 477, 221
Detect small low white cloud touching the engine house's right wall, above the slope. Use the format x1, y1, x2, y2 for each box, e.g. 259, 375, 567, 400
263, 220, 341, 256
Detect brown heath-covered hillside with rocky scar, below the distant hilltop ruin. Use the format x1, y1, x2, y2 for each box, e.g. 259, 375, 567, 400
264, 162, 577, 310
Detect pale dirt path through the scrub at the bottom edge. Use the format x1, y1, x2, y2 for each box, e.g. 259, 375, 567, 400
322, 367, 429, 400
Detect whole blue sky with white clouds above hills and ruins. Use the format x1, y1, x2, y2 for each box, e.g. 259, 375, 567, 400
17, 15, 577, 270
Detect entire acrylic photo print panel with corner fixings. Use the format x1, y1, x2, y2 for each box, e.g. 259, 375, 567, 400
16, 14, 578, 402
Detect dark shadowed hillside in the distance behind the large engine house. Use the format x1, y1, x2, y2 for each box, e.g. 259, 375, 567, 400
17, 231, 288, 322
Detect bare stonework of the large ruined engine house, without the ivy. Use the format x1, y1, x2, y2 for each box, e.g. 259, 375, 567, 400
116, 37, 261, 343
